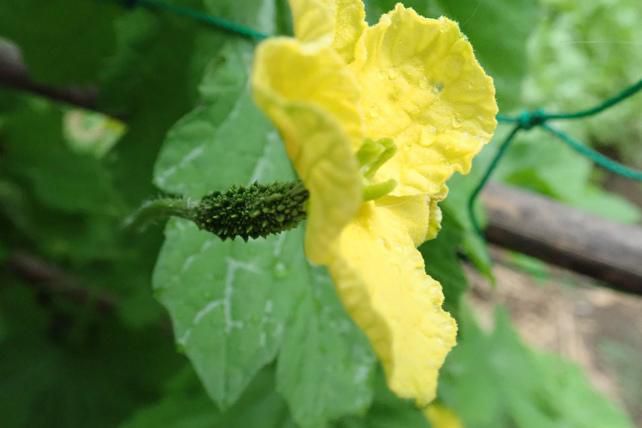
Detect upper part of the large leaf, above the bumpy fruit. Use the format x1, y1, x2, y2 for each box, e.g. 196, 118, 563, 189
154, 42, 280, 197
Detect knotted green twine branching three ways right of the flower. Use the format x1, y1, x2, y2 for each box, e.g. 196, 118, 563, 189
468, 80, 642, 238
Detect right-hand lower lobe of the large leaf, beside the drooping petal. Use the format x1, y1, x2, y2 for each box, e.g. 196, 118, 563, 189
277, 262, 375, 427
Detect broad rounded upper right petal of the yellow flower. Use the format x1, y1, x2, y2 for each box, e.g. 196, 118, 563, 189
351, 4, 497, 196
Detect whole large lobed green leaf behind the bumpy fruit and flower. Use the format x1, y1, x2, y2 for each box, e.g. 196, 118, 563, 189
154, 42, 374, 426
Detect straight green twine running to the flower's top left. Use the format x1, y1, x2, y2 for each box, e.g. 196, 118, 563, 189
121, 0, 269, 41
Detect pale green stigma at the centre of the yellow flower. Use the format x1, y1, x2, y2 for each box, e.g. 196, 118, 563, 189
357, 138, 397, 201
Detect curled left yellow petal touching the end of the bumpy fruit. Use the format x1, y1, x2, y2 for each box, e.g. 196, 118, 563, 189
252, 38, 362, 264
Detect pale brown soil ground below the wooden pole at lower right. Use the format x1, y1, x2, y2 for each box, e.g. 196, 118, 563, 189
468, 249, 642, 427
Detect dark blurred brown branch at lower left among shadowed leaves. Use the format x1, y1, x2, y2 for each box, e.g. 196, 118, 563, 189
6, 252, 116, 312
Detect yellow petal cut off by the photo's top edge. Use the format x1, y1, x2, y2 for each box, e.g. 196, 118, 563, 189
290, 0, 366, 62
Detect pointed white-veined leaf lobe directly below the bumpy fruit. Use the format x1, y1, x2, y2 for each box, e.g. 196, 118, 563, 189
154, 221, 300, 408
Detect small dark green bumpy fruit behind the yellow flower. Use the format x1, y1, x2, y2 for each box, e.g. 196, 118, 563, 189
194, 182, 308, 241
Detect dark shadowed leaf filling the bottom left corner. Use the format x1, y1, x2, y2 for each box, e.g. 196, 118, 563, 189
0, 290, 178, 428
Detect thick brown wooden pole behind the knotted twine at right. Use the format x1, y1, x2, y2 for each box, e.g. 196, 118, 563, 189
482, 183, 642, 295
